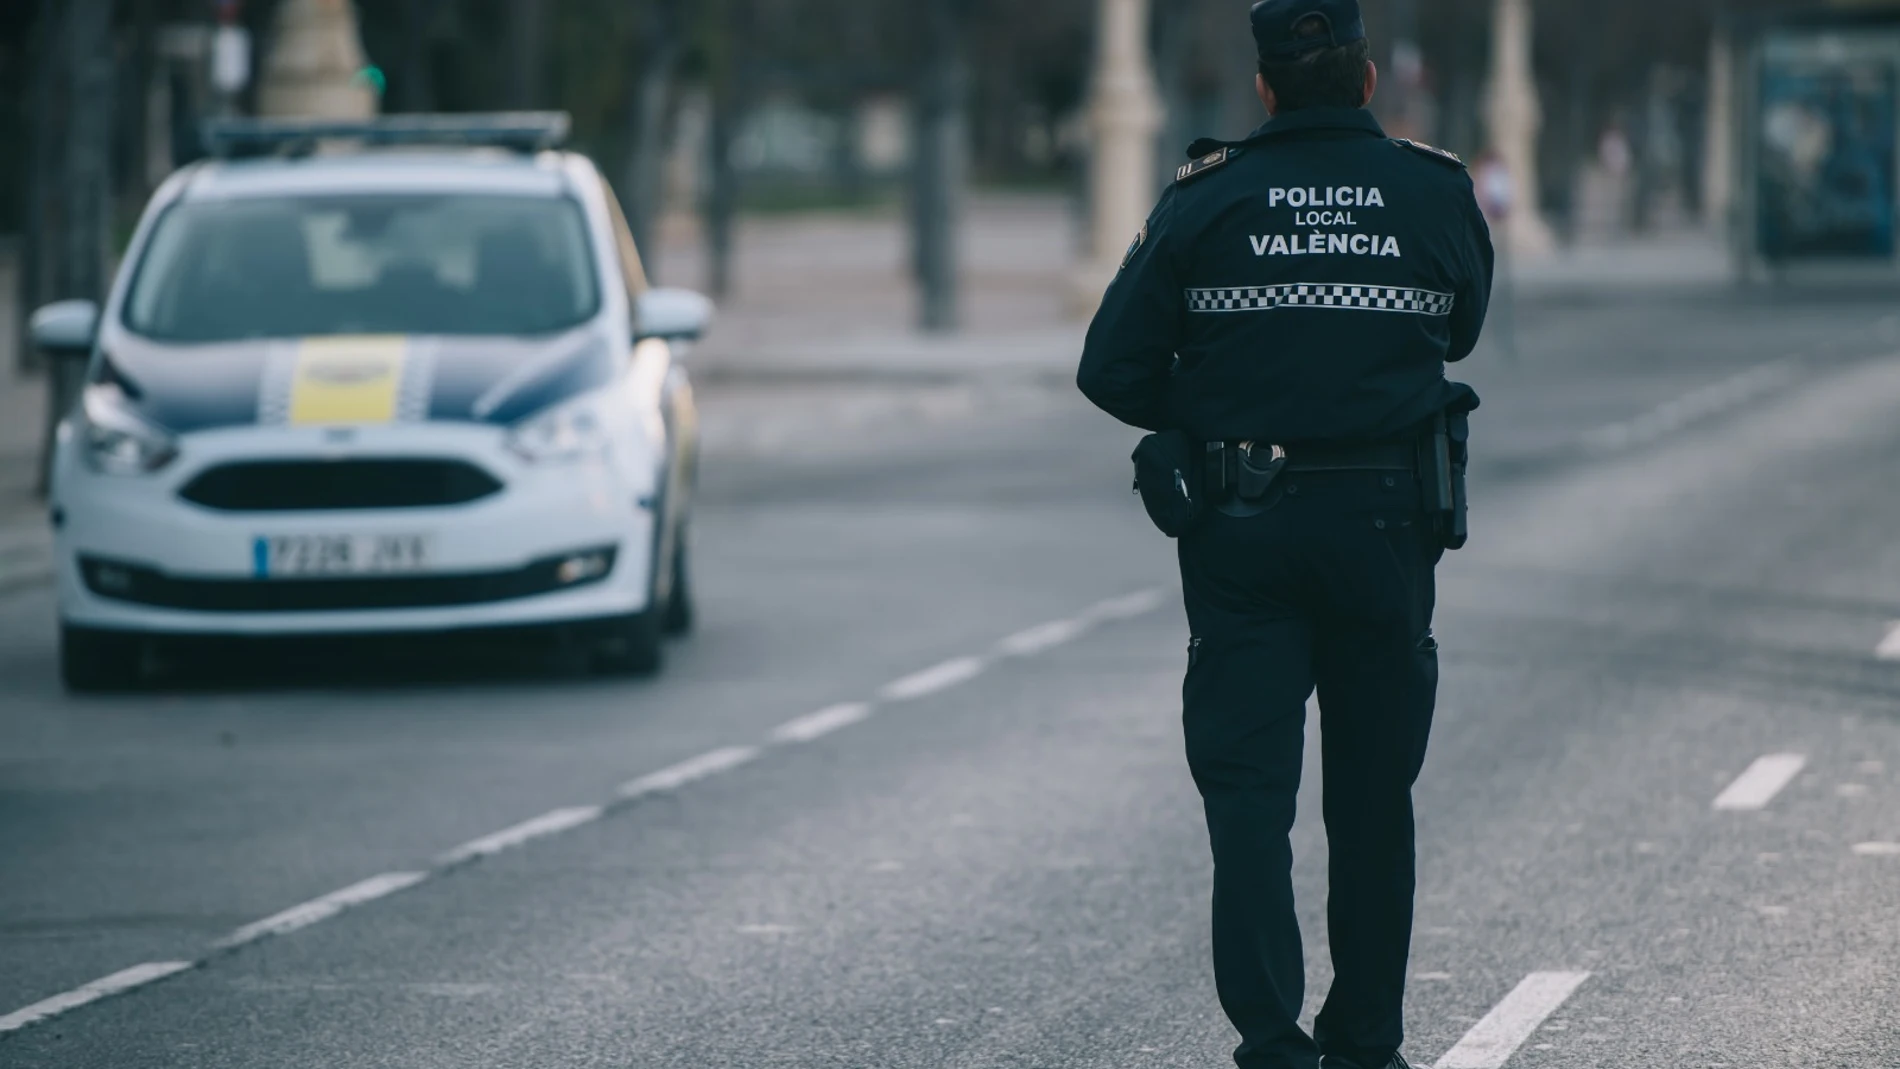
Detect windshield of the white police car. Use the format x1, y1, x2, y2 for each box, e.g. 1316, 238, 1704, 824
125, 196, 600, 342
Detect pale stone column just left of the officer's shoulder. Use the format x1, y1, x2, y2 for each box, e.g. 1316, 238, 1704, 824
1072, 0, 1163, 315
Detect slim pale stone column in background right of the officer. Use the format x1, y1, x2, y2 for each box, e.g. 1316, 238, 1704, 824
1484, 0, 1556, 256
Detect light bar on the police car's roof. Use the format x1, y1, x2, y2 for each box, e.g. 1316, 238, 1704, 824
203, 112, 572, 159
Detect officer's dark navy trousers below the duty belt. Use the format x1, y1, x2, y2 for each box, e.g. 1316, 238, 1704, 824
1180, 471, 1440, 1069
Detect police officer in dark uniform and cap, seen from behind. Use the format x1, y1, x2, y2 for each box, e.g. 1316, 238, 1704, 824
1077, 0, 1493, 1069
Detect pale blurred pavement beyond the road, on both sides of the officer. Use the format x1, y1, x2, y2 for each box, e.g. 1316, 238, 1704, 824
654, 194, 1729, 385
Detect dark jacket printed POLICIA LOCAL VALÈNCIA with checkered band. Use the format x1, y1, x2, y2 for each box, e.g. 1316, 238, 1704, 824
1077, 108, 1493, 444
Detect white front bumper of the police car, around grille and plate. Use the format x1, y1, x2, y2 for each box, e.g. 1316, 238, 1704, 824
53, 423, 656, 636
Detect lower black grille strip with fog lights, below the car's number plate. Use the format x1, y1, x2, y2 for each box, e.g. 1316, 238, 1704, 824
80, 547, 616, 613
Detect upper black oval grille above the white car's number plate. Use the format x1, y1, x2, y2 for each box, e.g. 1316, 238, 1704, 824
179, 458, 502, 513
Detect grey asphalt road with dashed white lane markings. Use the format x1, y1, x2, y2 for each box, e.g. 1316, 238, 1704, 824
0, 294, 1900, 1069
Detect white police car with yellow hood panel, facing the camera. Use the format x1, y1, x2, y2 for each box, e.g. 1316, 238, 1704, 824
32, 114, 711, 691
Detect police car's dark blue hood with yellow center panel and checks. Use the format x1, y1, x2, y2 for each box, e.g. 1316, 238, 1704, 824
97, 328, 618, 433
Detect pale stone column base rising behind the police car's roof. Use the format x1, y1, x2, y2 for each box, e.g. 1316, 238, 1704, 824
257, 0, 376, 120
